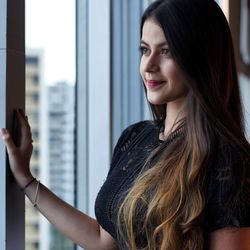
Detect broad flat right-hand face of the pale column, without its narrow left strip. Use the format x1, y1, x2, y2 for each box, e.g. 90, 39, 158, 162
88, 0, 111, 215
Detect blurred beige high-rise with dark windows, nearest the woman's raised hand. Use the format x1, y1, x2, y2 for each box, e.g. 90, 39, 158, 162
25, 51, 41, 250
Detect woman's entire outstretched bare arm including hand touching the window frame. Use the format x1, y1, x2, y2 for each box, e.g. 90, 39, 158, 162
0, 111, 118, 250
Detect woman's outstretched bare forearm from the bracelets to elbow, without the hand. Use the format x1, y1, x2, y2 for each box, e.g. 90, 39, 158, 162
25, 182, 117, 250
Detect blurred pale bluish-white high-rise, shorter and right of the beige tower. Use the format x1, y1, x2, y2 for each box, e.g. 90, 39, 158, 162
47, 82, 75, 250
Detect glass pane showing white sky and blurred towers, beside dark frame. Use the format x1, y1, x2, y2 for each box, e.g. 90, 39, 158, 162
25, 0, 75, 250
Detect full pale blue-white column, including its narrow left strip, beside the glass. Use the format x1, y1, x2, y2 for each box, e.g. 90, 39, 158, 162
77, 0, 111, 224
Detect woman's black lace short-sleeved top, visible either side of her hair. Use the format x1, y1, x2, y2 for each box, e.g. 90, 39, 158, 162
95, 121, 250, 249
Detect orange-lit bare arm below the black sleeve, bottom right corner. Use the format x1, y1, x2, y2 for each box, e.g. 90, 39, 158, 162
209, 227, 250, 250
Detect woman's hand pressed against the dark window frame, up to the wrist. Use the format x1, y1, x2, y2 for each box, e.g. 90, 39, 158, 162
0, 110, 33, 187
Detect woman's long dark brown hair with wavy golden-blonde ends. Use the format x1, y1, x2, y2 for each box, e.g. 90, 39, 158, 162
118, 0, 249, 250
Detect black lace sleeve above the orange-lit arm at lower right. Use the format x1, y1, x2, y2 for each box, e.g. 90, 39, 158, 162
205, 146, 250, 231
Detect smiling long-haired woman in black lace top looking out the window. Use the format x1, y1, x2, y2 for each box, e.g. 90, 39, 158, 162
1, 0, 250, 250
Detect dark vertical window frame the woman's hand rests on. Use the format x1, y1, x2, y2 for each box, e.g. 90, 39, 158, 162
0, 0, 25, 250
